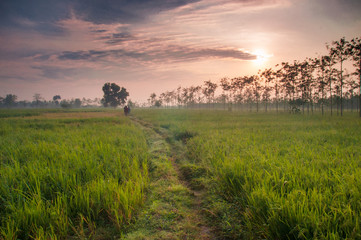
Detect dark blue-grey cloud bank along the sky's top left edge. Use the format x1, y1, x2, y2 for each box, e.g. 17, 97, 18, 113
0, 0, 199, 31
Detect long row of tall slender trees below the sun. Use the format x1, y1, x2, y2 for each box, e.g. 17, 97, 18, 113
148, 37, 361, 117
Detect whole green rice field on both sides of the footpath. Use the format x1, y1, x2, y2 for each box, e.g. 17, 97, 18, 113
0, 109, 361, 239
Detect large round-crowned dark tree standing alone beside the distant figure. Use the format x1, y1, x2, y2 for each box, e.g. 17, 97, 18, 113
102, 83, 129, 108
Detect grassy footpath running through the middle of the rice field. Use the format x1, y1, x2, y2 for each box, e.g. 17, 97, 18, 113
122, 117, 217, 239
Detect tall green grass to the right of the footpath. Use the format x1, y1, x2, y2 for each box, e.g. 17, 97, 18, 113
137, 110, 361, 239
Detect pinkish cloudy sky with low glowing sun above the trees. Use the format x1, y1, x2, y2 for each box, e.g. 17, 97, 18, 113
0, 0, 361, 103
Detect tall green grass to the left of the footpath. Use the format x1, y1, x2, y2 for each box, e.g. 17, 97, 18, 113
0, 111, 149, 239
